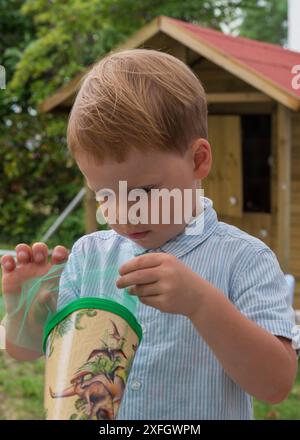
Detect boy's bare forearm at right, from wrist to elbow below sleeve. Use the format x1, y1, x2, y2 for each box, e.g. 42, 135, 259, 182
190, 280, 297, 403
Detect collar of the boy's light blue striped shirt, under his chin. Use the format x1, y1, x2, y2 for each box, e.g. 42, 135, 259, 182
130, 196, 218, 258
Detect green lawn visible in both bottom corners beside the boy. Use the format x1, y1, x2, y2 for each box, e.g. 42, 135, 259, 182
0, 245, 300, 420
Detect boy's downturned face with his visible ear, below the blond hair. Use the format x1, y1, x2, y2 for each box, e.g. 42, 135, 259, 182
76, 139, 211, 248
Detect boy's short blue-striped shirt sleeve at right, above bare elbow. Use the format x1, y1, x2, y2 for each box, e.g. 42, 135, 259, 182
230, 248, 295, 340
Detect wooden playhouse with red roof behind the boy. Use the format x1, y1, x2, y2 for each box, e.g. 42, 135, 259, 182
40, 16, 300, 308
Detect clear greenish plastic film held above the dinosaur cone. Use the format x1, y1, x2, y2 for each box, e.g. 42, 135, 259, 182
0, 248, 138, 359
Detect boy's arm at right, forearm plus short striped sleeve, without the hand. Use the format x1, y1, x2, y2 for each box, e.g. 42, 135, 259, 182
189, 252, 297, 403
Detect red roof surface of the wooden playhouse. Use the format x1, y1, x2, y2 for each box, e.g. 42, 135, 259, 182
169, 18, 300, 98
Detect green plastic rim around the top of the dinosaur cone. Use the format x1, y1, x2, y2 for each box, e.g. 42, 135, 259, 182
43, 297, 143, 353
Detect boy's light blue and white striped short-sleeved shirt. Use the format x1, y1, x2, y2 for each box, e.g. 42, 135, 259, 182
59, 197, 294, 420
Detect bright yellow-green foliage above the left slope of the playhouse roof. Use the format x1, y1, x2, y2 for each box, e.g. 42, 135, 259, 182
9, 0, 124, 105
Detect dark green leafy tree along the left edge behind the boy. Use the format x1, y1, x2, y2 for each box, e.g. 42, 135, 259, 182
0, 0, 83, 248
